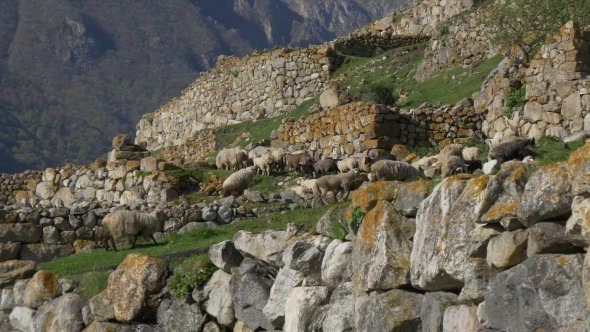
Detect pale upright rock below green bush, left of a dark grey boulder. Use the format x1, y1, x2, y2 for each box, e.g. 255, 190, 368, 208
203, 270, 236, 327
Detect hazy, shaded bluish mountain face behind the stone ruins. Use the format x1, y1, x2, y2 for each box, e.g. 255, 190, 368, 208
0, 0, 405, 173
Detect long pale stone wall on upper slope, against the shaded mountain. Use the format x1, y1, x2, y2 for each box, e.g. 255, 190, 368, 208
136, 48, 333, 150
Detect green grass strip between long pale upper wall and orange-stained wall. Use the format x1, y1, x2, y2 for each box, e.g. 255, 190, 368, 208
207, 95, 320, 157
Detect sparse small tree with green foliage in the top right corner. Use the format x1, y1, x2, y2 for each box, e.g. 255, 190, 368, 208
483, 0, 590, 62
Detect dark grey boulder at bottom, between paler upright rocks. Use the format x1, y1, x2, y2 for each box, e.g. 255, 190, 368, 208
231, 268, 274, 330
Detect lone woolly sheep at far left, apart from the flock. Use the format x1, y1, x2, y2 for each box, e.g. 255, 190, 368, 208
102, 210, 161, 251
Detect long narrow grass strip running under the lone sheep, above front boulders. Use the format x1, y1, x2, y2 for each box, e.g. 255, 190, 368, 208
37, 202, 348, 275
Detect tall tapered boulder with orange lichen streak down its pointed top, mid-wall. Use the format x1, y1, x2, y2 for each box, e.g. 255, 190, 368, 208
351, 201, 412, 291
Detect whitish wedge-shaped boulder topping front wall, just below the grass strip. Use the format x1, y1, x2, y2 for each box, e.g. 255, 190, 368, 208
233, 231, 288, 274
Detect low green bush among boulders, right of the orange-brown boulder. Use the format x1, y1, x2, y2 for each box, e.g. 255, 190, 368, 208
168, 254, 217, 299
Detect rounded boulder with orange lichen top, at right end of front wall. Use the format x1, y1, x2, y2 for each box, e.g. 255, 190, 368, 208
517, 162, 574, 227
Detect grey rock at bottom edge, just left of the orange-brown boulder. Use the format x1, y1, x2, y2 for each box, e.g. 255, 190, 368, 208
34, 293, 85, 332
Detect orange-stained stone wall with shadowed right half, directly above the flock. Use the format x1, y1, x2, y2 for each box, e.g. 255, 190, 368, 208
272, 99, 484, 158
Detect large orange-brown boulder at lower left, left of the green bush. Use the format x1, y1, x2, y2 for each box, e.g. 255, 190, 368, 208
107, 254, 168, 322
